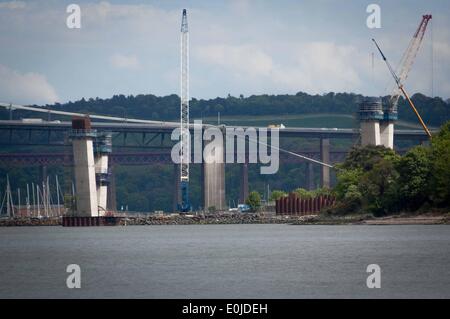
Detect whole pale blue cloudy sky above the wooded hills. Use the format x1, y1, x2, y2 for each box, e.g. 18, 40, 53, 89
0, 0, 450, 104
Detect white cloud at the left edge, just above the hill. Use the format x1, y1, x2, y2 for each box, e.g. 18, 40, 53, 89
0, 64, 58, 104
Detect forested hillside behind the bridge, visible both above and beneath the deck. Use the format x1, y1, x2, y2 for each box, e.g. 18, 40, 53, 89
0, 92, 450, 211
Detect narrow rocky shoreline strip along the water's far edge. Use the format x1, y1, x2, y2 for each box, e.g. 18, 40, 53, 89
0, 213, 450, 227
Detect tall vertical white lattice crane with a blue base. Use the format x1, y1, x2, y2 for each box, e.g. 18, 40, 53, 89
178, 9, 191, 212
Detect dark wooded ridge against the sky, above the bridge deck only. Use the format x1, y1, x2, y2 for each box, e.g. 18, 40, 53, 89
0, 92, 450, 126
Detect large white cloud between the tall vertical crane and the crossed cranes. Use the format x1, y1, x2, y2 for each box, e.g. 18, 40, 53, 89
195, 42, 365, 93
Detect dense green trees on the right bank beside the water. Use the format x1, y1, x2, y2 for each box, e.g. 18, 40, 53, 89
334, 121, 450, 216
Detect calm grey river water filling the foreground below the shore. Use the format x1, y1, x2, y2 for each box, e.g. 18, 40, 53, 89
0, 225, 450, 298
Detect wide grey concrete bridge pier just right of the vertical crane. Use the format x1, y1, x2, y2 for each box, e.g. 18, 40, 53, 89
203, 140, 225, 210
